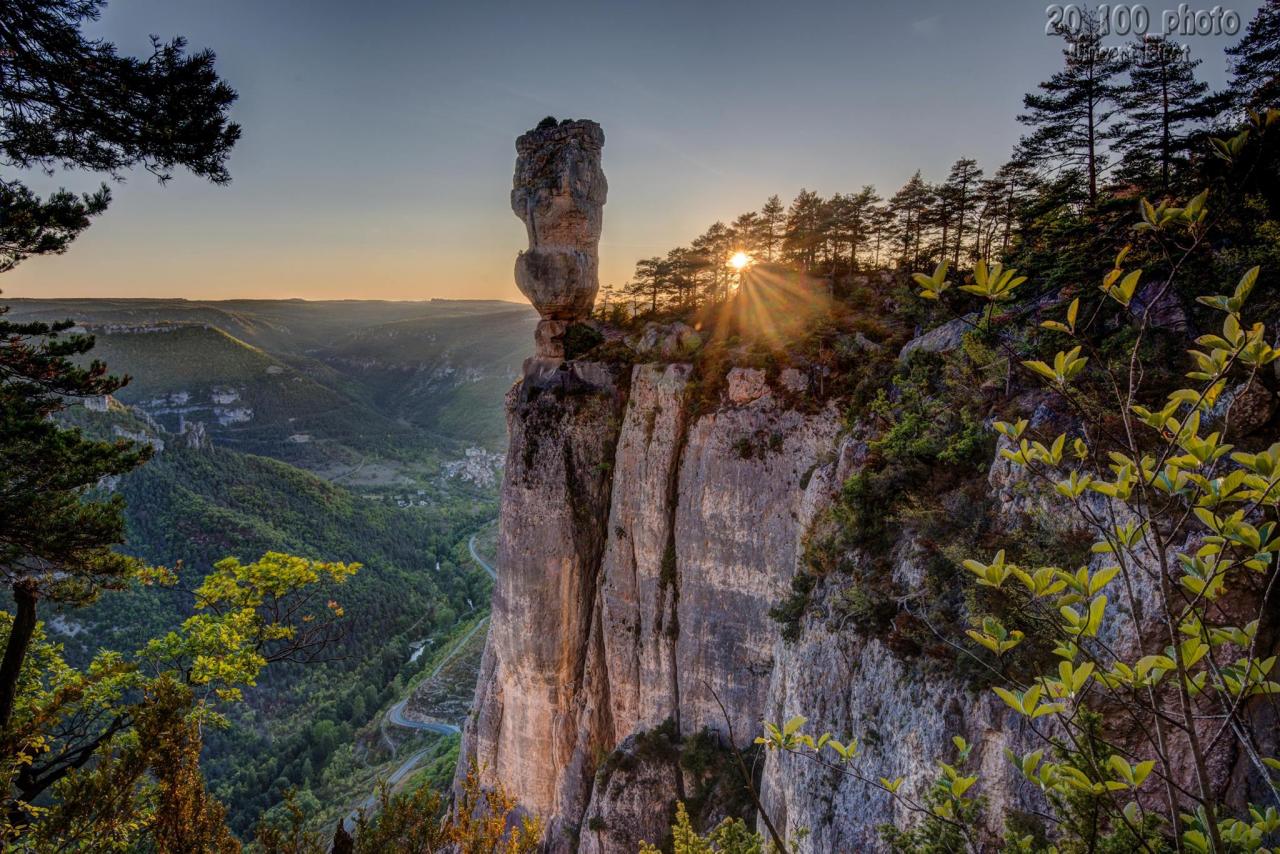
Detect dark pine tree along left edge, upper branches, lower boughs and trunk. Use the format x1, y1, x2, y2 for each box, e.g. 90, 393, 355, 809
0, 0, 239, 727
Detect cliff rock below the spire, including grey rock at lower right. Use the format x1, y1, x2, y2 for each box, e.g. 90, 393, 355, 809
460, 348, 1276, 854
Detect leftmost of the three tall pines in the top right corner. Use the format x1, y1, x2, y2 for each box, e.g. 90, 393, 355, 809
1018, 13, 1128, 205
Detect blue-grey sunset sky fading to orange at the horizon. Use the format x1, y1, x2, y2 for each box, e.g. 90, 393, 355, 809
0, 0, 1258, 306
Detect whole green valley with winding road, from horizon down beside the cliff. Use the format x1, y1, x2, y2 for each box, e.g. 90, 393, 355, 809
12, 300, 532, 839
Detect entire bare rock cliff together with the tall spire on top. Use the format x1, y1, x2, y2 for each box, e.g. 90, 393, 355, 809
458, 119, 1276, 854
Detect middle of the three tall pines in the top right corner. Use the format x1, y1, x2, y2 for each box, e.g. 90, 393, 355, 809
1119, 37, 1220, 192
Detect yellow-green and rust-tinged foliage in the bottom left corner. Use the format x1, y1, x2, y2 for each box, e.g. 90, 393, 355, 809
0, 552, 360, 851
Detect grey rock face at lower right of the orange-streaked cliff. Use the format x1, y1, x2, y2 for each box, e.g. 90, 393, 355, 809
762, 612, 1030, 851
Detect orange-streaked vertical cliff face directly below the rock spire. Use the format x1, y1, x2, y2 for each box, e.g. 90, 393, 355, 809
463, 362, 840, 851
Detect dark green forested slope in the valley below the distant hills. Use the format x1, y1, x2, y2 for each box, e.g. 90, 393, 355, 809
50, 373, 497, 834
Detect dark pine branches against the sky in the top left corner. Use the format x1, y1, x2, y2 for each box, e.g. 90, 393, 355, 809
0, 0, 239, 273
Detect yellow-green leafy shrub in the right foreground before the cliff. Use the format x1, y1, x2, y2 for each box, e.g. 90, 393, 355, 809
762, 181, 1280, 853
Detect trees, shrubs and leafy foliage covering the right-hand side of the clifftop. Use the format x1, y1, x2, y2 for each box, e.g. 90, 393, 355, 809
650, 3, 1280, 853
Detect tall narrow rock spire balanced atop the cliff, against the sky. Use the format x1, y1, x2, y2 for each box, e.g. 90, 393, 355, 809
511, 118, 609, 359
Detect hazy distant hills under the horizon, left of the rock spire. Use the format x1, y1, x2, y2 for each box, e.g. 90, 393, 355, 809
10, 300, 536, 488
